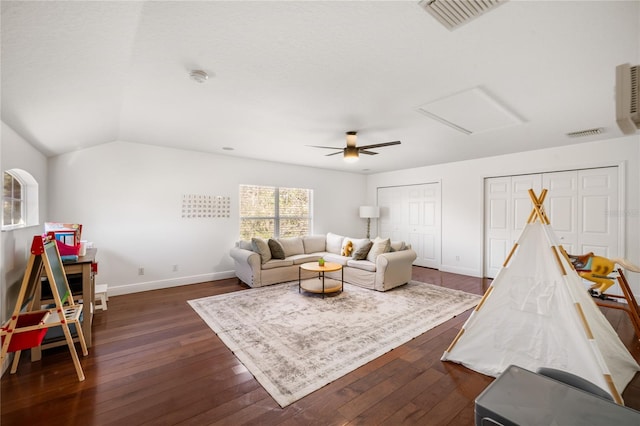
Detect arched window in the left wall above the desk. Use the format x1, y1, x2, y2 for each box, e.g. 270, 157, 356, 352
2, 169, 39, 231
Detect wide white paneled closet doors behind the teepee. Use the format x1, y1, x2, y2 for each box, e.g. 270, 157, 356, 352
484, 167, 621, 293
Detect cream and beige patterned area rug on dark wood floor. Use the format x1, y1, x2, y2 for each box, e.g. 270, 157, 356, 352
188, 281, 480, 407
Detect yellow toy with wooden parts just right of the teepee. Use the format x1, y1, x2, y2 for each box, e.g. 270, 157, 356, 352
569, 253, 640, 295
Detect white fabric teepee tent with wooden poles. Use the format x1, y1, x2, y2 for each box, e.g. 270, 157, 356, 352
441, 189, 640, 404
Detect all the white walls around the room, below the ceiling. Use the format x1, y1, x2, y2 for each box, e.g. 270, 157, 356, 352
2, 124, 640, 300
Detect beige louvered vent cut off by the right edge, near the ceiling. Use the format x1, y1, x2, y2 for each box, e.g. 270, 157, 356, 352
616, 64, 640, 135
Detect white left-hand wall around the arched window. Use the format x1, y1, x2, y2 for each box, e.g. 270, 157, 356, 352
0, 122, 47, 321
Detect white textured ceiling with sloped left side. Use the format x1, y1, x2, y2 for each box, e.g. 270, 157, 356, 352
1, 0, 640, 173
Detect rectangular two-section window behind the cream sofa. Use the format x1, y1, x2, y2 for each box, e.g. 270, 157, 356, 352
240, 185, 313, 240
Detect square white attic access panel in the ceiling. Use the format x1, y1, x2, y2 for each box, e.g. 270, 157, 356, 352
417, 87, 524, 135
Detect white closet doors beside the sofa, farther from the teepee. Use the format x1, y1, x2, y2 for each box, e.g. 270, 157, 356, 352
378, 182, 442, 269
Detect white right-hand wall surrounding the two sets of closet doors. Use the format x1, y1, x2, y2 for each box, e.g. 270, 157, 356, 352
367, 135, 640, 294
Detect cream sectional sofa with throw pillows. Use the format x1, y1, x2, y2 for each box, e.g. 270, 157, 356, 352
230, 233, 416, 291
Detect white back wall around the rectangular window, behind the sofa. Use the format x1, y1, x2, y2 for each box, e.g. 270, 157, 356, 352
47, 142, 366, 295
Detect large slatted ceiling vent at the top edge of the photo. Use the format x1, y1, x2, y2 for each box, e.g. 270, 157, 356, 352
418, 0, 507, 30
